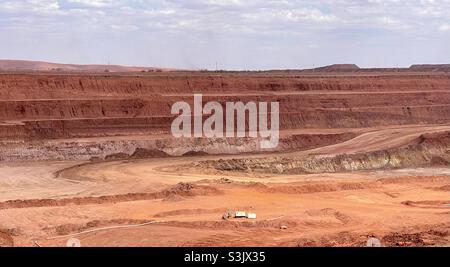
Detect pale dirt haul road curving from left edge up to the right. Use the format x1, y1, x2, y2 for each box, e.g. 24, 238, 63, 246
0, 125, 450, 201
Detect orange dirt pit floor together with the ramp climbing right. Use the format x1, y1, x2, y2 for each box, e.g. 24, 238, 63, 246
0, 125, 450, 246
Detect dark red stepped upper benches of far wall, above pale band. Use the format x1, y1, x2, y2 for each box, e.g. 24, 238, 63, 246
0, 74, 450, 136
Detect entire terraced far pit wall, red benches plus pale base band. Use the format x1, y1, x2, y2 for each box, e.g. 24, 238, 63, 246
0, 72, 450, 160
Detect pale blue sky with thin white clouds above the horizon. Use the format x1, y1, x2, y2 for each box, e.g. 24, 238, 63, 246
0, 0, 450, 69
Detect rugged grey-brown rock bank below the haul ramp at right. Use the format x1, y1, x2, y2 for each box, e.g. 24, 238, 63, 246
200, 132, 450, 174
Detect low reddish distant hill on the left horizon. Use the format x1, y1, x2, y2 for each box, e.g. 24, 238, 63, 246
0, 59, 175, 72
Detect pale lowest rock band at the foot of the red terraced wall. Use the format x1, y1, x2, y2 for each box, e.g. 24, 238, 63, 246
0, 133, 356, 161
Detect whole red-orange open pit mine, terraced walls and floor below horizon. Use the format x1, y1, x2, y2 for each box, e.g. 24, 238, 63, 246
0, 66, 450, 247
